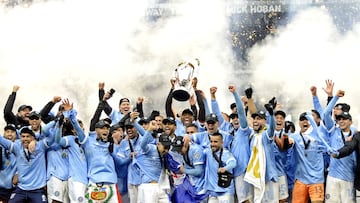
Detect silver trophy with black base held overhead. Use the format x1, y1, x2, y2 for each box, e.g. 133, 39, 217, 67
172, 59, 200, 101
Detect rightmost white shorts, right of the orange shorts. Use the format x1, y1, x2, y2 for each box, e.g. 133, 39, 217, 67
325, 176, 355, 203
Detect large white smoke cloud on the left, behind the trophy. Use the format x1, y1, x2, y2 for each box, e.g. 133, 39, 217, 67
0, 0, 235, 127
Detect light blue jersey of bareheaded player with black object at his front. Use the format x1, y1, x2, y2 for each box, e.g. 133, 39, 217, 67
205, 148, 236, 196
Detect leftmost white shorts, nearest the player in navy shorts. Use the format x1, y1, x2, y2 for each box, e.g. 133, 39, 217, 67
46, 176, 69, 203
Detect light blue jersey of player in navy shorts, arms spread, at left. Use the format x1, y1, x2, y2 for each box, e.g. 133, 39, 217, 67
0, 136, 53, 190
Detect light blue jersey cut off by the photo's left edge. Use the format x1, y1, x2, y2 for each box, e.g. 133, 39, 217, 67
0, 147, 16, 190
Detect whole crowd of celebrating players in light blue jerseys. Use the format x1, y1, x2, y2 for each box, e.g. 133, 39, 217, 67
0, 80, 360, 203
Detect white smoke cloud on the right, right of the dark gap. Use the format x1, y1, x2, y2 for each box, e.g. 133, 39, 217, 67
249, 7, 360, 127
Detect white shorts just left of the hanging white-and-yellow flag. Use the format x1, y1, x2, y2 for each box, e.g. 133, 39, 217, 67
234, 174, 254, 202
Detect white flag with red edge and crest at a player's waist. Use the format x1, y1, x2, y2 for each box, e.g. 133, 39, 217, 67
85, 183, 121, 203
